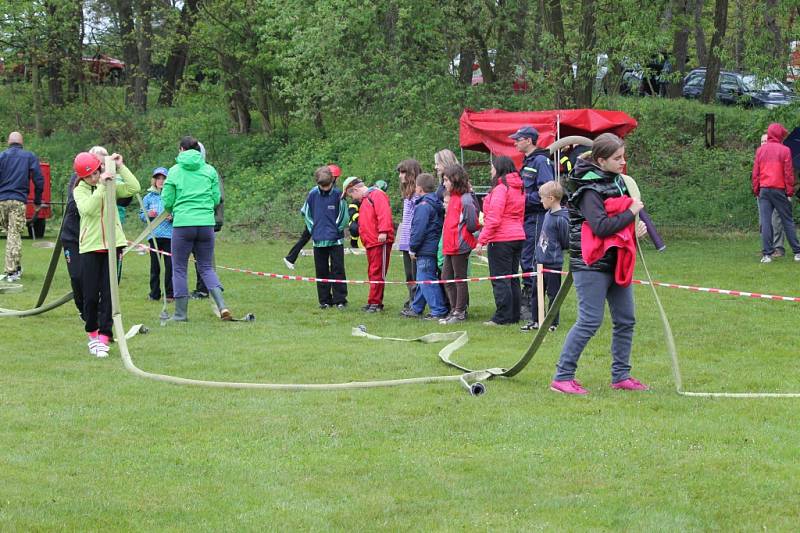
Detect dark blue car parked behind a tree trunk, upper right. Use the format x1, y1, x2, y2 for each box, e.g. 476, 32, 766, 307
683, 68, 797, 109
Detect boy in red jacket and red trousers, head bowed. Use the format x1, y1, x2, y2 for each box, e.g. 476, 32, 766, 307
342, 176, 394, 313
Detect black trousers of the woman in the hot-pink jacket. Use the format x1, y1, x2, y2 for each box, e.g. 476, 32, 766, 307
487, 240, 525, 324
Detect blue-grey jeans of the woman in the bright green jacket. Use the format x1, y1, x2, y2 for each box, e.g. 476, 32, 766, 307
172, 226, 221, 298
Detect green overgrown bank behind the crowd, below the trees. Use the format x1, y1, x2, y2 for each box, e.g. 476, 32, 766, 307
0, 84, 800, 236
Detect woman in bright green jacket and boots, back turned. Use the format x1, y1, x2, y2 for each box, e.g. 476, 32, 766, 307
161, 136, 232, 322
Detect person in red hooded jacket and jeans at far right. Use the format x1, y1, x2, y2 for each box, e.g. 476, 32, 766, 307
753, 122, 800, 263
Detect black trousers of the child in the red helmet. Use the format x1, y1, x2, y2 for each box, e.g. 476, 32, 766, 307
81, 248, 122, 337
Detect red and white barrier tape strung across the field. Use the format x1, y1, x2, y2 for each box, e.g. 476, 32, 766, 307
131, 244, 800, 302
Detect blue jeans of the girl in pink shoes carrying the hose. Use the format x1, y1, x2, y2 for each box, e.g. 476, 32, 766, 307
553, 271, 636, 383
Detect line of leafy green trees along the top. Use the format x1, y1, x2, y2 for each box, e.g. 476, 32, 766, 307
0, 0, 800, 133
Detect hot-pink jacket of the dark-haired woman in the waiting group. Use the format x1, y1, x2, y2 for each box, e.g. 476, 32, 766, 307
478, 172, 525, 245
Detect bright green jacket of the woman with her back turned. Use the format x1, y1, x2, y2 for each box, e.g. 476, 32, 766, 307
161, 150, 220, 228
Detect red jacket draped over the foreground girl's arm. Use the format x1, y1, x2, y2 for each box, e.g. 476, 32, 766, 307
581, 196, 636, 287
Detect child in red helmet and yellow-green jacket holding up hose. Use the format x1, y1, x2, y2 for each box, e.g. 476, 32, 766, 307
73, 152, 141, 357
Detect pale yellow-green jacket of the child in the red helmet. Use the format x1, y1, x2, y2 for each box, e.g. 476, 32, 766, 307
72, 165, 142, 254
